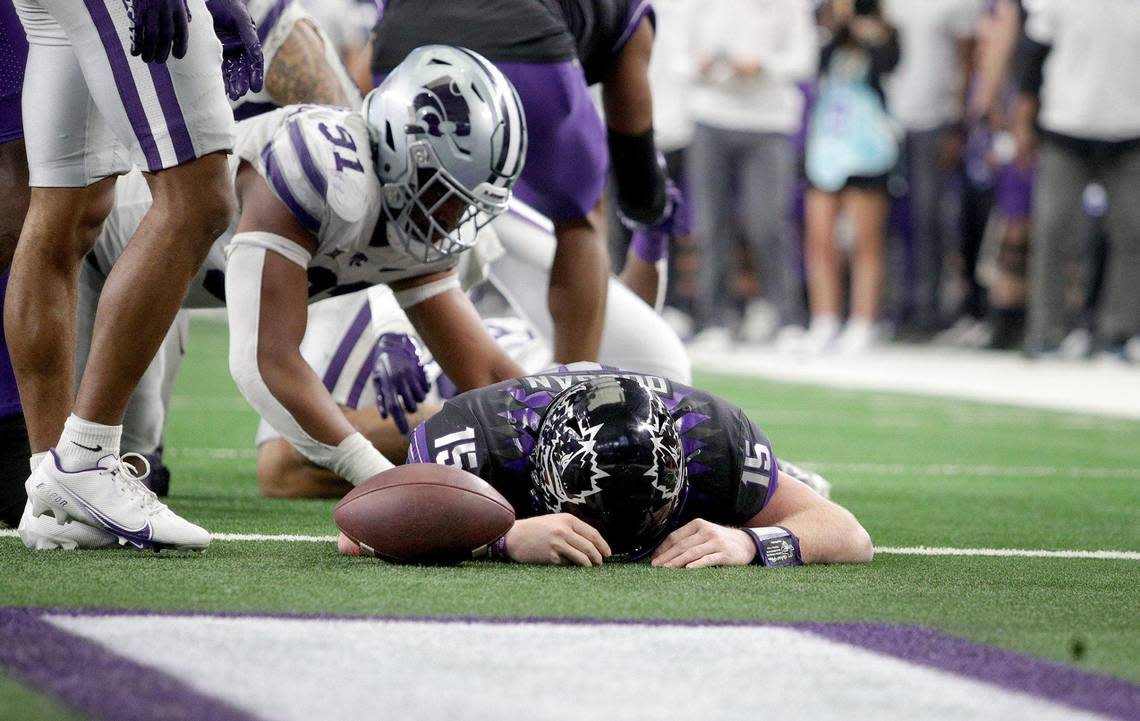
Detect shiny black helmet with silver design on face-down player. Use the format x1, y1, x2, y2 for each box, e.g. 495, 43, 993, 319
531, 375, 687, 561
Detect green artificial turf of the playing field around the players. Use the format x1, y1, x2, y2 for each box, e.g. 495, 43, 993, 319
0, 322, 1140, 707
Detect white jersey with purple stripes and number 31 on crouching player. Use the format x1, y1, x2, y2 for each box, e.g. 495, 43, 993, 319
234, 105, 458, 302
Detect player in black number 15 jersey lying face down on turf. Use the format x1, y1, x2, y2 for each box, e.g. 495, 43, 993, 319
340, 364, 874, 568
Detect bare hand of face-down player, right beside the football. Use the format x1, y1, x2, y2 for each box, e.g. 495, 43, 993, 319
506, 513, 610, 566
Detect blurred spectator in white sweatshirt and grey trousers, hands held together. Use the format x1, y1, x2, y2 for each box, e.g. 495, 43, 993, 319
687, 0, 819, 346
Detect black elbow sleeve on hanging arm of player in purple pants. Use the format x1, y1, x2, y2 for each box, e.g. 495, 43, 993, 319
606, 128, 668, 225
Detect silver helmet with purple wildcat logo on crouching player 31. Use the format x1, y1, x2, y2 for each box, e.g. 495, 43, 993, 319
363, 44, 527, 262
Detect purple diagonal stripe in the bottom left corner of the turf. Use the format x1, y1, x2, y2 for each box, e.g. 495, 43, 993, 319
0, 608, 259, 721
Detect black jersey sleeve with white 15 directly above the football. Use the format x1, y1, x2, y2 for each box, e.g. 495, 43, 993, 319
407, 403, 491, 480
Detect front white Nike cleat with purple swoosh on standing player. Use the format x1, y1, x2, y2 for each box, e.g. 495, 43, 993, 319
24, 449, 210, 550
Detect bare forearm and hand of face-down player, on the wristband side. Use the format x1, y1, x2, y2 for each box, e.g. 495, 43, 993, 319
653, 472, 874, 568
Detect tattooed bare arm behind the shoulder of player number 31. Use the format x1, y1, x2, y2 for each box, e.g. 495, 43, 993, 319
266, 21, 350, 107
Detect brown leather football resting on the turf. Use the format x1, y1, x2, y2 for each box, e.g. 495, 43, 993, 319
333, 463, 514, 564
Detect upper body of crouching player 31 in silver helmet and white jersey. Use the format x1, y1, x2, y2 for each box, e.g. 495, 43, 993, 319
18, 46, 527, 548
